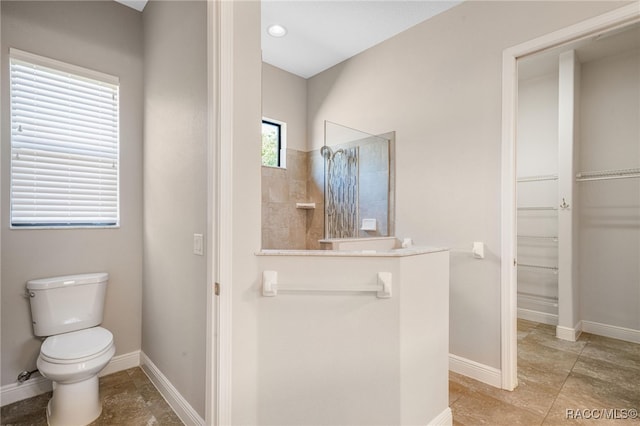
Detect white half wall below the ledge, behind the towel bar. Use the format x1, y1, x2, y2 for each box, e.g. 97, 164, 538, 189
257, 251, 449, 426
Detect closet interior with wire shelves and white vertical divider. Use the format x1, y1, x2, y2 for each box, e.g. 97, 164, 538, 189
516, 25, 640, 341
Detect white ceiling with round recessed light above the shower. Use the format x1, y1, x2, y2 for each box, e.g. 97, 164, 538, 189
262, 0, 462, 78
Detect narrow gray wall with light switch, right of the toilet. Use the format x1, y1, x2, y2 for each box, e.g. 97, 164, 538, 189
142, 1, 208, 418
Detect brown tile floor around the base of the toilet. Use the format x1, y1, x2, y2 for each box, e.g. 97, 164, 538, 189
0, 367, 183, 426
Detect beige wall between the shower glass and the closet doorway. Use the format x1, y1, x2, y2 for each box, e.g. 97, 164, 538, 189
308, 1, 625, 368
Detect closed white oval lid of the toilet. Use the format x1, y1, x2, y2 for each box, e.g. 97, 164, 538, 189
40, 327, 113, 360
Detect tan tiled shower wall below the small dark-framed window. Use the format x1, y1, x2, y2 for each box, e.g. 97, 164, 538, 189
262, 149, 324, 250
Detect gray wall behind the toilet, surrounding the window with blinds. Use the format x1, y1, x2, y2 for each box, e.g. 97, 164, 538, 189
0, 1, 142, 385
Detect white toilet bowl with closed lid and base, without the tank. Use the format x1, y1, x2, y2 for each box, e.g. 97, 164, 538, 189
37, 327, 116, 426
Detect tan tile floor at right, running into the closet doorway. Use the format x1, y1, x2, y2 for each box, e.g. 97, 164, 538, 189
449, 320, 640, 426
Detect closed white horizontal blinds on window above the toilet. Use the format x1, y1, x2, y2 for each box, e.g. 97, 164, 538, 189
10, 49, 119, 227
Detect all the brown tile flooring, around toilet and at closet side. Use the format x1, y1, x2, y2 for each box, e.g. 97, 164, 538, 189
0, 320, 640, 426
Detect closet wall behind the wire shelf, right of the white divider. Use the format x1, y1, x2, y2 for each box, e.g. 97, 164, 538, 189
579, 50, 640, 330
